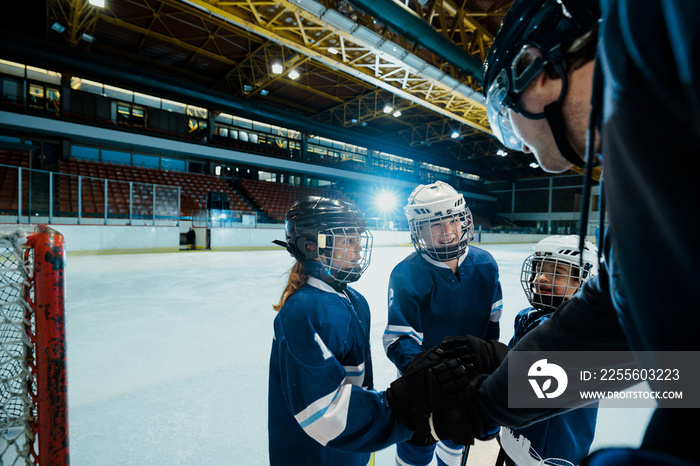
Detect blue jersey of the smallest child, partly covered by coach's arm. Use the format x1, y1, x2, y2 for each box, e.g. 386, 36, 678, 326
501, 307, 598, 466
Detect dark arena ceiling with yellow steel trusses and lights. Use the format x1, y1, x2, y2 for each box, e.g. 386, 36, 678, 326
6, 0, 592, 180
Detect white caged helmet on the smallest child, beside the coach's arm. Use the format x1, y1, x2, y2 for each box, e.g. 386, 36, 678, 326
520, 235, 598, 311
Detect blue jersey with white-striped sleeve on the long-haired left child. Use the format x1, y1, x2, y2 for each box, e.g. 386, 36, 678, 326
268, 278, 412, 466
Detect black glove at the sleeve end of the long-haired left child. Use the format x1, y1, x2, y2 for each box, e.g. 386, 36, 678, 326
386, 347, 477, 431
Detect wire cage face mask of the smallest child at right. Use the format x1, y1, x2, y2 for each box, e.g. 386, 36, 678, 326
520, 253, 591, 312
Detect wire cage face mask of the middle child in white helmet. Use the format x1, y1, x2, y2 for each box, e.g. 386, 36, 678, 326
409, 207, 474, 262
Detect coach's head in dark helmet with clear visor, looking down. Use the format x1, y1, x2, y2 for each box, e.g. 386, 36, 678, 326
483, 1, 600, 172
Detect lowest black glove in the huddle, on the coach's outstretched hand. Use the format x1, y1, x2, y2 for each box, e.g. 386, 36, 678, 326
429, 374, 497, 445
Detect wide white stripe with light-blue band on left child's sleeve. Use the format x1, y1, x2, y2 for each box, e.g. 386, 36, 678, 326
294, 384, 352, 446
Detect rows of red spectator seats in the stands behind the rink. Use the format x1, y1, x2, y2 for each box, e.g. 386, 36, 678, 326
0, 150, 358, 221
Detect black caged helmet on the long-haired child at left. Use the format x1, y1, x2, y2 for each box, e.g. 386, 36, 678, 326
284, 196, 372, 283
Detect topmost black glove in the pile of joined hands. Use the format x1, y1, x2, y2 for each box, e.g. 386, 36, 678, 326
437, 335, 509, 374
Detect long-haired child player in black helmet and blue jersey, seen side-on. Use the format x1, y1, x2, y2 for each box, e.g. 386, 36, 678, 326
268, 197, 412, 466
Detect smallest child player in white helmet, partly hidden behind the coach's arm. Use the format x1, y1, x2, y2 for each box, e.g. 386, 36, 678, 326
498, 235, 598, 466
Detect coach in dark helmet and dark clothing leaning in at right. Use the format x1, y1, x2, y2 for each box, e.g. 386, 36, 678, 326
382, 0, 700, 466
